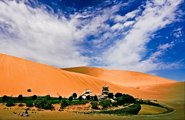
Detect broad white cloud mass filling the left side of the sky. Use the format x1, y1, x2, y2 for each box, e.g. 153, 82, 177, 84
0, 1, 89, 67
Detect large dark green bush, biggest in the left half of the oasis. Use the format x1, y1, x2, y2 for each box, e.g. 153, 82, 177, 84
34, 97, 53, 109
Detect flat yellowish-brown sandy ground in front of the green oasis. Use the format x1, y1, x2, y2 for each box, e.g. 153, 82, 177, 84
0, 101, 185, 120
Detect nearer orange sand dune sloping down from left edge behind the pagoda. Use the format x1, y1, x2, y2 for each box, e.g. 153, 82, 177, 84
0, 54, 155, 97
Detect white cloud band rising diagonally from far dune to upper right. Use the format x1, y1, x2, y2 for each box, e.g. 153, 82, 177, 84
103, 0, 181, 72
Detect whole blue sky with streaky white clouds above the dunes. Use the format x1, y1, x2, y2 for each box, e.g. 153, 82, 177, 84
0, 0, 185, 81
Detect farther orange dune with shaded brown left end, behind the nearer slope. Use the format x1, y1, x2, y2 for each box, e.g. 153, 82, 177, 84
63, 67, 176, 87
